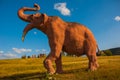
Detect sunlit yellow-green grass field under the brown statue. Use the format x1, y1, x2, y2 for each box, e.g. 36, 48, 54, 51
0, 56, 120, 80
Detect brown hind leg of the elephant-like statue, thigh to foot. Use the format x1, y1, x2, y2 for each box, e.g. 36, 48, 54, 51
84, 40, 99, 71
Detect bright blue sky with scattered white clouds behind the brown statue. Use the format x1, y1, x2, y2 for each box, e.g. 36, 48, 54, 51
0, 0, 120, 59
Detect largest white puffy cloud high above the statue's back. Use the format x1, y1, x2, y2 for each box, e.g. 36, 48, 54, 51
54, 3, 70, 16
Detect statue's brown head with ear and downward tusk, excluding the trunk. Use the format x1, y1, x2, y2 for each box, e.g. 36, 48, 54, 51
22, 13, 48, 41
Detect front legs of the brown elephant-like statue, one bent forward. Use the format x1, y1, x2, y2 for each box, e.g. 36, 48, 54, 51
44, 45, 62, 74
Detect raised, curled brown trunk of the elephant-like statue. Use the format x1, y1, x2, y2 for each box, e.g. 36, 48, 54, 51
18, 4, 40, 22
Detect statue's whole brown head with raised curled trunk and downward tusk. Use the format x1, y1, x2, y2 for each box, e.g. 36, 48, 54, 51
18, 4, 48, 41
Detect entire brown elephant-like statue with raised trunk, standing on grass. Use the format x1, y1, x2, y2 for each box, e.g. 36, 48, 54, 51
18, 4, 98, 74
